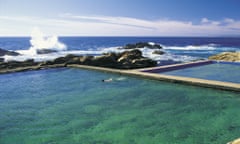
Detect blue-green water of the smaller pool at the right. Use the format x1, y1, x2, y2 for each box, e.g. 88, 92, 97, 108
162, 63, 240, 83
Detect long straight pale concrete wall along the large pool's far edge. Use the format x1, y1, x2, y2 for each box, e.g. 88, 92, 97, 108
68, 65, 240, 92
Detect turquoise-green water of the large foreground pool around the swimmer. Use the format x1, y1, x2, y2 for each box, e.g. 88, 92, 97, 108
0, 69, 240, 144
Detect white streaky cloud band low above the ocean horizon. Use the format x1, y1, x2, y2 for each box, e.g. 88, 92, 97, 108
0, 14, 240, 36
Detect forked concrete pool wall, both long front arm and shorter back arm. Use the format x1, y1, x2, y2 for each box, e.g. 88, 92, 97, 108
68, 61, 240, 92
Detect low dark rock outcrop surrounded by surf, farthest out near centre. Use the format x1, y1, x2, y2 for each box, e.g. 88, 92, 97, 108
123, 42, 162, 49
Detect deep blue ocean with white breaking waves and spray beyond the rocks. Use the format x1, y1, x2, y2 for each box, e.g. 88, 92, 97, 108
0, 36, 240, 64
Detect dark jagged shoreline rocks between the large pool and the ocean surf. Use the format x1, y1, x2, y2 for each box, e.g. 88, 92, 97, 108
0, 42, 164, 73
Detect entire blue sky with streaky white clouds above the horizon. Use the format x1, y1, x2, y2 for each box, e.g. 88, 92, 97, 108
0, 0, 240, 36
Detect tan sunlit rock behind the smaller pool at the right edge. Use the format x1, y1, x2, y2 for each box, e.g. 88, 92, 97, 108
208, 52, 240, 62
